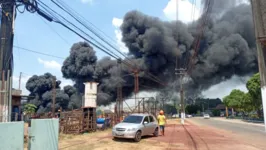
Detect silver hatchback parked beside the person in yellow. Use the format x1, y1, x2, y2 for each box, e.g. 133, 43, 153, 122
112, 114, 159, 142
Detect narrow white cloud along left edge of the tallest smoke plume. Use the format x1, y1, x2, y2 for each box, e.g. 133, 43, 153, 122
112, 18, 128, 53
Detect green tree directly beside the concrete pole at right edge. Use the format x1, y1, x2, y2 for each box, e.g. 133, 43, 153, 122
246, 73, 262, 117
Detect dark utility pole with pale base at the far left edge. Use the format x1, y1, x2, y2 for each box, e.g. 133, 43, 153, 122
0, 0, 15, 122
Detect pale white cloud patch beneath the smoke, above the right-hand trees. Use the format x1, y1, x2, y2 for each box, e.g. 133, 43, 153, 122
202, 76, 249, 99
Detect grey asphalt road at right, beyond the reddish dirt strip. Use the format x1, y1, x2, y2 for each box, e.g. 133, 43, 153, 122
189, 117, 266, 139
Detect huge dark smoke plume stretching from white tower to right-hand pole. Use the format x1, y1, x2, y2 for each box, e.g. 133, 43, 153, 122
62, 0, 258, 105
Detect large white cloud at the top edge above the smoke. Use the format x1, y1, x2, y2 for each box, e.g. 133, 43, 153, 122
163, 0, 200, 23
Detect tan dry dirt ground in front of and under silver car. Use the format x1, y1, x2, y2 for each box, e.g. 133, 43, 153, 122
59, 120, 179, 150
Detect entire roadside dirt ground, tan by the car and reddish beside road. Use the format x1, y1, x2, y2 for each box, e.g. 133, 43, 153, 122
59, 120, 264, 150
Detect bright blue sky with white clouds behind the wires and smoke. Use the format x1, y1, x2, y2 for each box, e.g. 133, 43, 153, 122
10, 0, 247, 99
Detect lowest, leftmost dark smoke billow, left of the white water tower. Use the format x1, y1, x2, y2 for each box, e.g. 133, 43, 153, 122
26, 73, 81, 113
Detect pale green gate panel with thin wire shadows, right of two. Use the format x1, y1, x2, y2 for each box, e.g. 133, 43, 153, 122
29, 119, 59, 150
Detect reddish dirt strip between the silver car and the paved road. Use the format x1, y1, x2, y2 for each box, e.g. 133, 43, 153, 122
148, 121, 263, 150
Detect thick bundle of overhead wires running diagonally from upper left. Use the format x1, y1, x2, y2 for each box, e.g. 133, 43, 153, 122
14, 0, 166, 86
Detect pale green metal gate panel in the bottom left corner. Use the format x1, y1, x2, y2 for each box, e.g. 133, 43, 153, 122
0, 121, 24, 150
